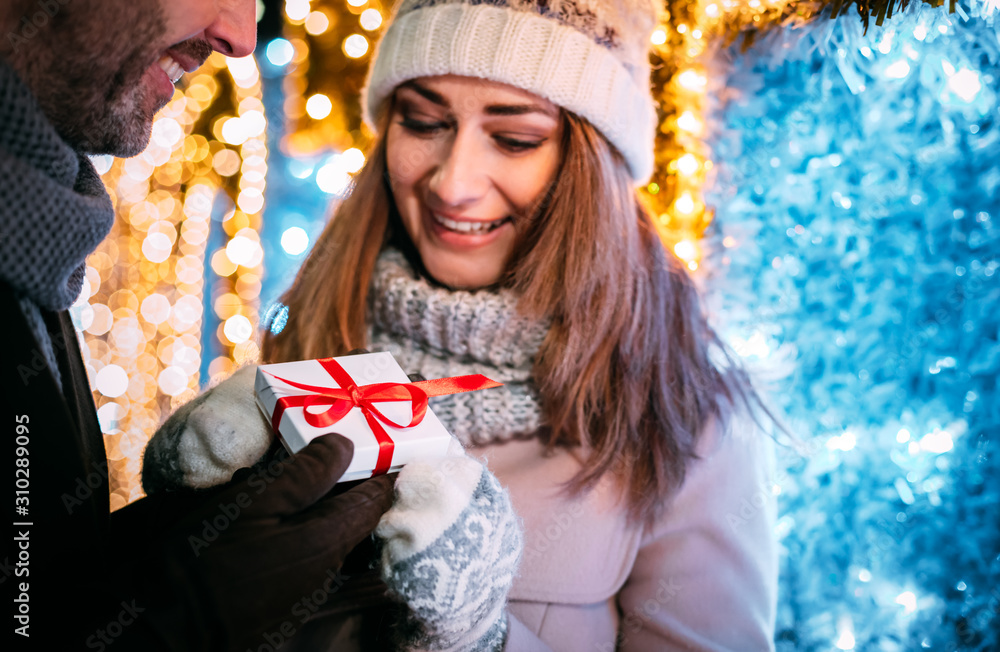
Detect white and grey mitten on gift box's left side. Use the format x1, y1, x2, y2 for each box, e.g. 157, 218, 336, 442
142, 366, 274, 494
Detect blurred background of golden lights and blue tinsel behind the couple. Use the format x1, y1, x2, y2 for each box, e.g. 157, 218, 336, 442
73, 0, 1000, 651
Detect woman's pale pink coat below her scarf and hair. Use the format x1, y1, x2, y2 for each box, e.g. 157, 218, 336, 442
469, 416, 777, 652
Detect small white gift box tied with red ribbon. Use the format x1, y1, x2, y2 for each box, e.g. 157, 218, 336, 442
254, 353, 451, 482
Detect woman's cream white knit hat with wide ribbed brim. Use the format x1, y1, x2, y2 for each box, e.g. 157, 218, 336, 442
366, 0, 657, 183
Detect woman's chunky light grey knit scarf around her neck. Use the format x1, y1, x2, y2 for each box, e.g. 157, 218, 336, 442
368, 249, 548, 445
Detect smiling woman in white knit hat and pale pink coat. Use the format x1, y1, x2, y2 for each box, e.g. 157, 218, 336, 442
147, 0, 777, 650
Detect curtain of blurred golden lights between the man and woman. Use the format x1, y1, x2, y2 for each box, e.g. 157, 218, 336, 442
78, 55, 267, 509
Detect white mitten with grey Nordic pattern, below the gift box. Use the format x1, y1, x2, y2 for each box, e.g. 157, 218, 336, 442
375, 440, 523, 652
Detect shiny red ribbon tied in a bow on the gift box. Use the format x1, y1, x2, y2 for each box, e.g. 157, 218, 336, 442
268, 358, 501, 476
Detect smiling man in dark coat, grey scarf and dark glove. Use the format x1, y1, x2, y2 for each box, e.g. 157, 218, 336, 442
0, 0, 392, 651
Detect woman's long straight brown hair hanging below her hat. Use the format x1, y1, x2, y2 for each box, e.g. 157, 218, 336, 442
263, 105, 760, 520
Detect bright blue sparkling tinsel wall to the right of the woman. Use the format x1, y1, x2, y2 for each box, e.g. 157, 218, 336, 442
705, 4, 1000, 650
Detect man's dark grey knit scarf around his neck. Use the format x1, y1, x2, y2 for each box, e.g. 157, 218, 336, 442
0, 60, 114, 379
